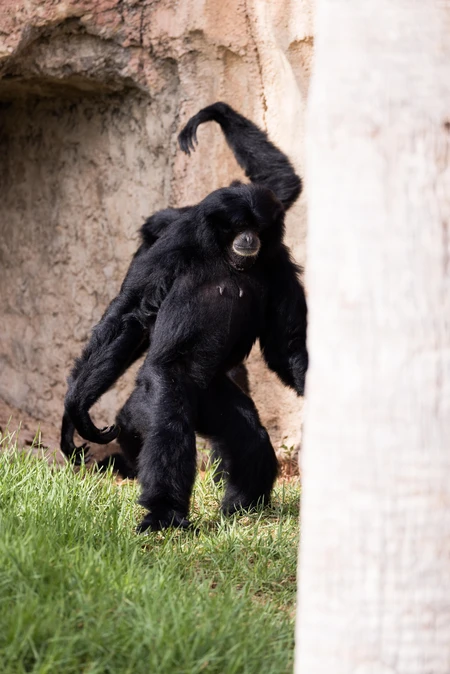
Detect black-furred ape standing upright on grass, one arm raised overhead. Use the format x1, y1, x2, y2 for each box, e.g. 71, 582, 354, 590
62, 103, 307, 530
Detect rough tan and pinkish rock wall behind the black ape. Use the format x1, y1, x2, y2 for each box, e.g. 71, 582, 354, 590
0, 0, 313, 447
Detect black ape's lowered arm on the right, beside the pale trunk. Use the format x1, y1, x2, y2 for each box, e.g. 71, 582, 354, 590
259, 246, 308, 395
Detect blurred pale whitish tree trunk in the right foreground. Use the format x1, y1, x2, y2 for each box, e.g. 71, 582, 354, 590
296, 0, 450, 674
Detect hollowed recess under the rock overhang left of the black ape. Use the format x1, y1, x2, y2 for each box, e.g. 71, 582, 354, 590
0, 31, 174, 434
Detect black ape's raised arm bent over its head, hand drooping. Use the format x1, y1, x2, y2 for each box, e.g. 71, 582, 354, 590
178, 103, 302, 210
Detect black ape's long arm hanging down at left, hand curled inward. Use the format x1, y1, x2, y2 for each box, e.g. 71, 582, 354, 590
63, 217, 190, 444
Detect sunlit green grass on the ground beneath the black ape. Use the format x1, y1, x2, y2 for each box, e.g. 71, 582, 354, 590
0, 430, 299, 674
